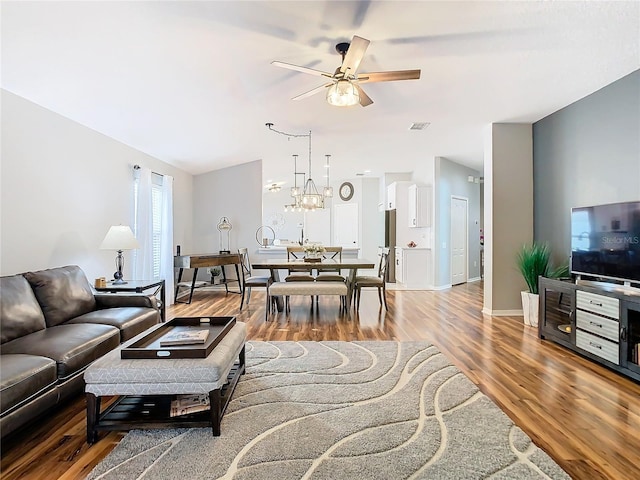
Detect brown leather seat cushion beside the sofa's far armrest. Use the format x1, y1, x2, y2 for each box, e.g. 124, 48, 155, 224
65, 307, 160, 342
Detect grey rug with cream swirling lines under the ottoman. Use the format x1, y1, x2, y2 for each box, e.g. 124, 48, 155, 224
88, 341, 569, 480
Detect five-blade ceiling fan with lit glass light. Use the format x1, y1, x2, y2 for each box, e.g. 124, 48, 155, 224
271, 35, 420, 107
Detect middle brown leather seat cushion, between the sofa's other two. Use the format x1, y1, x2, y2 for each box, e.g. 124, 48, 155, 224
2, 323, 120, 378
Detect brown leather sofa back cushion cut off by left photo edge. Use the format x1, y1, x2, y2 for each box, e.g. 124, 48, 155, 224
0, 275, 46, 343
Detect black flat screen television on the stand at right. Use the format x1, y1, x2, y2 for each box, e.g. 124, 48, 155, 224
571, 201, 640, 283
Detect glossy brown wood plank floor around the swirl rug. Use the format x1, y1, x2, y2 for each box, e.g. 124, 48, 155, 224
1, 283, 640, 480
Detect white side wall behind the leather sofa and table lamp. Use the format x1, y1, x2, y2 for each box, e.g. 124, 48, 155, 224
0, 90, 192, 281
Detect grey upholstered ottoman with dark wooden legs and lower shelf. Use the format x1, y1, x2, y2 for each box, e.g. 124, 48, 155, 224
84, 322, 246, 444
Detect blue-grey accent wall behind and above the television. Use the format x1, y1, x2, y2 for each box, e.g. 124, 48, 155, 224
533, 70, 640, 261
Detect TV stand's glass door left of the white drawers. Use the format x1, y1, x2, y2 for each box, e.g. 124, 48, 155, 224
538, 278, 576, 346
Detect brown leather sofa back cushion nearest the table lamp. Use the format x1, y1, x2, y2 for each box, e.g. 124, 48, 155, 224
24, 265, 96, 327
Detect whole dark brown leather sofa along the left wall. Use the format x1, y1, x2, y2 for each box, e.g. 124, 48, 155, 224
0, 265, 160, 438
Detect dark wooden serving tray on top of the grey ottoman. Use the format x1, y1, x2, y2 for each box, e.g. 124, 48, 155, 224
120, 317, 236, 359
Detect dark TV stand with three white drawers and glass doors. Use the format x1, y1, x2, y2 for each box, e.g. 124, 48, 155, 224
538, 277, 640, 382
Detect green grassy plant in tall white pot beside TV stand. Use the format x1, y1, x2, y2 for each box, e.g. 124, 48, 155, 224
517, 242, 569, 327
